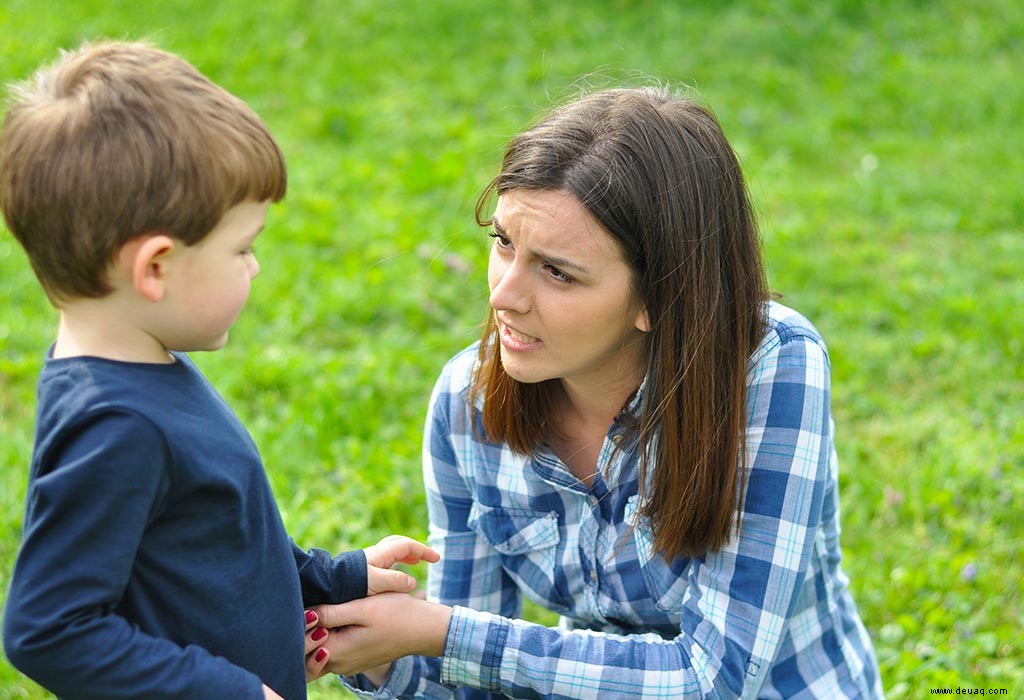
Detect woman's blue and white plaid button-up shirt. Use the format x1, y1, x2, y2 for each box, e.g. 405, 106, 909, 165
348, 303, 883, 698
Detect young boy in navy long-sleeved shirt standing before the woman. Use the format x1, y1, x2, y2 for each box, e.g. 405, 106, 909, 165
0, 43, 437, 700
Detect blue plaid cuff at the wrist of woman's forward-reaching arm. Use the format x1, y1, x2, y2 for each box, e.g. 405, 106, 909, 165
441, 606, 511, 691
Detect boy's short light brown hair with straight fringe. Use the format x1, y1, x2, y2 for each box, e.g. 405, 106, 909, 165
0, 42, 287, 303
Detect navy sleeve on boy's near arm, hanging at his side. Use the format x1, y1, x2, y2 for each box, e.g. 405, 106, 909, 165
3, 412, 263, 700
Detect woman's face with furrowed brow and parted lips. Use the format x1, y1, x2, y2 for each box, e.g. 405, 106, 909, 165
487, 189, 647, 389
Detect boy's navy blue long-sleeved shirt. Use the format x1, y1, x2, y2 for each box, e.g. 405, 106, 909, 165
3, 354, 367, 700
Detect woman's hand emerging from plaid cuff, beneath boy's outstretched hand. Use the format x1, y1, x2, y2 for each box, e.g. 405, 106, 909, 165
307, 593, 452, 682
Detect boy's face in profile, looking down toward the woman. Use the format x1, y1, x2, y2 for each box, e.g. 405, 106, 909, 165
162, 201, 270, 351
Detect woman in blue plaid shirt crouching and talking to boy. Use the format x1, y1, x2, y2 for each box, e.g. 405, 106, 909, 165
309, 89, 882, 698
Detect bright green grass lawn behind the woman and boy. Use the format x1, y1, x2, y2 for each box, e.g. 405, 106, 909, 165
0, 0, 1024, 699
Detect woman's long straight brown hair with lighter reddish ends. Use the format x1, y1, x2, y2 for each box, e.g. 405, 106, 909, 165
470, 88, 768, 557
